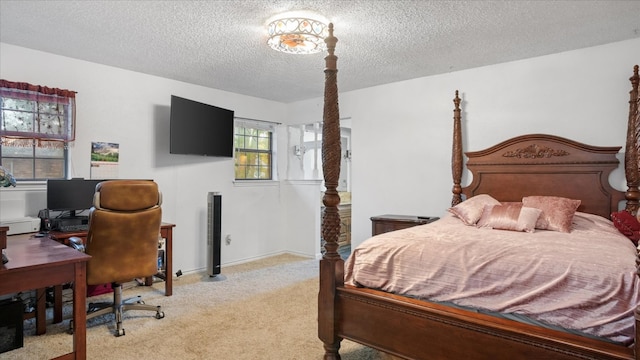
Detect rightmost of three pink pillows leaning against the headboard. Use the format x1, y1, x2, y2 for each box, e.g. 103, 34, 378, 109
522, 196, 581, 232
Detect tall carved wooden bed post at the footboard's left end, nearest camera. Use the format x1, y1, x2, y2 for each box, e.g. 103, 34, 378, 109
318, 24, 344, 360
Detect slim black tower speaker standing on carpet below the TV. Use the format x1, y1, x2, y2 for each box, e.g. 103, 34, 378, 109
207, 192, 222, 276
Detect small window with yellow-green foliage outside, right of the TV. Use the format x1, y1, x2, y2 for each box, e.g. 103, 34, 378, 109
234, 118, 275, 180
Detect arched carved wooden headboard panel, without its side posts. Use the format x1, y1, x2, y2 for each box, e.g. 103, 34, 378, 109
462, 134, 624, 218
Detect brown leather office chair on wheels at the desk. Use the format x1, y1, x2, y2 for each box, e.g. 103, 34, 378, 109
70, 180, 164, 336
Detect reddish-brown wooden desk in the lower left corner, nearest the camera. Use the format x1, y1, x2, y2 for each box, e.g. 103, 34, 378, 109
0, 231, 91, 359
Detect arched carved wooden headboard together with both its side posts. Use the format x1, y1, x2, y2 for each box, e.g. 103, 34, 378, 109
452, 65, 640, 218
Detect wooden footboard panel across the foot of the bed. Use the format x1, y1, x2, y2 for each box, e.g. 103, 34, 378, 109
336, 286, 634, 360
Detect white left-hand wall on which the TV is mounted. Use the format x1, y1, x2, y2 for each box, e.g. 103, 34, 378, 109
0, 43, 296, 272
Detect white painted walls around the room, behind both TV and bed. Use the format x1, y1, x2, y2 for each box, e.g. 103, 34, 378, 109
0, 39, 640, 271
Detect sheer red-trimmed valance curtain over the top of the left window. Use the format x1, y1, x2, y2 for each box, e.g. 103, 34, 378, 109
0, 79, 76, 147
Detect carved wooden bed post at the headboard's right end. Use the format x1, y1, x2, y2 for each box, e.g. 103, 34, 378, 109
624, 65, 640, 215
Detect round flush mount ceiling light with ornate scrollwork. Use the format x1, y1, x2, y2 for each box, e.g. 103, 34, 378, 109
267, 17, 328, 54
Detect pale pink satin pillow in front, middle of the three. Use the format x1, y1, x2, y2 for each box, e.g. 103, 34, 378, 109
477, 203, 542, 233
